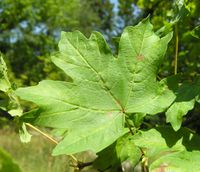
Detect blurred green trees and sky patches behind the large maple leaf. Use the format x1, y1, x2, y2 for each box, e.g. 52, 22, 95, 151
0, 0, 200, 171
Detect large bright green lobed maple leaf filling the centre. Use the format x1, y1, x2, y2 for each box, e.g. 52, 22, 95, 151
16, 19, 175, 155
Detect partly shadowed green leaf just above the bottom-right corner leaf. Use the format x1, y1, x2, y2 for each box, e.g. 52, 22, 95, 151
133, 127, 200, 165
